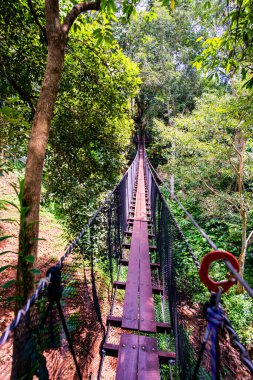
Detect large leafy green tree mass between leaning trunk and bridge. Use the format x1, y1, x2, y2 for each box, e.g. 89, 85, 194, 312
44, 23, 140, 233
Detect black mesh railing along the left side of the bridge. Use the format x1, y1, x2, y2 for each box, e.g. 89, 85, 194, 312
0, 154, 138, 380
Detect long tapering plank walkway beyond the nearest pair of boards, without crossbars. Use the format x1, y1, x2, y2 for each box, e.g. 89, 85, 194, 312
122, 150, 156, 332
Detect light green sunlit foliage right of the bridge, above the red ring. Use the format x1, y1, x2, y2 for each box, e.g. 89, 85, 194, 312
150, 87, 253, 232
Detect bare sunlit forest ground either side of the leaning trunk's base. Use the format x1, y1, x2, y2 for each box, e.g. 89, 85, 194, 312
0, 173, 67, 334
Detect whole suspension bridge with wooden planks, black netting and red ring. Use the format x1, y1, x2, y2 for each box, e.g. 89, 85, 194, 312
0, 146, 253, 380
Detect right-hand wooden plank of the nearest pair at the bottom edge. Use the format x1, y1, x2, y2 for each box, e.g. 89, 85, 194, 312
138, 336, 160, 380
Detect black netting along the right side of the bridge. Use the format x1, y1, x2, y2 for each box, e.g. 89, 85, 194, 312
145, 153, 252, 380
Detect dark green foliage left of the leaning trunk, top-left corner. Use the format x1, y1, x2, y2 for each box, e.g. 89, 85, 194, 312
0, 0, 46, 162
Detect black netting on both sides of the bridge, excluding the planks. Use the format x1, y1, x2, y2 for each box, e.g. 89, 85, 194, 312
0, 149, 251, 380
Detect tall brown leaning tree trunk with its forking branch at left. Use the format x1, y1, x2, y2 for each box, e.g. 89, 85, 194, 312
16, 0, 100, 309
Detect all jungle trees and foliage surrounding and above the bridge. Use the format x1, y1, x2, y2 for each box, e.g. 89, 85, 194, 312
0, 0, 253, 344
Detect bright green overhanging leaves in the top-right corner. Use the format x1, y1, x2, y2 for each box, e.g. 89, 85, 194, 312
195, 0, 253, 88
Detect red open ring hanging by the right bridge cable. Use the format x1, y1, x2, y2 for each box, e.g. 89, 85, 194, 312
199, 251, 240, 293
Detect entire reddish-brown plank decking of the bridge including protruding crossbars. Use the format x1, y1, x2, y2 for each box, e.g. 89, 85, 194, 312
104, 149, 175, 380
